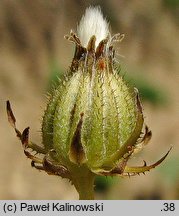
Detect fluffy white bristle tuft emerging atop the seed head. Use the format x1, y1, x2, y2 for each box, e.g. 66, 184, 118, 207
77, 7, 109, 47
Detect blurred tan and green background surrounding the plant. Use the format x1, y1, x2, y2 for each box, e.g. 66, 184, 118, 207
0, 0, 179, 199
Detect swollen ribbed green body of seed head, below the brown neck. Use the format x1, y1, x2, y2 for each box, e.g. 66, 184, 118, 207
42, 66, 138, 170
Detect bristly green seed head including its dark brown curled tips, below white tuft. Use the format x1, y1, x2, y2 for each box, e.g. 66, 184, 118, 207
42, 8, 143, 172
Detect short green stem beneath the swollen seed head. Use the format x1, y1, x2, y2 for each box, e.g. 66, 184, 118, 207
72, 167, 95, 200
